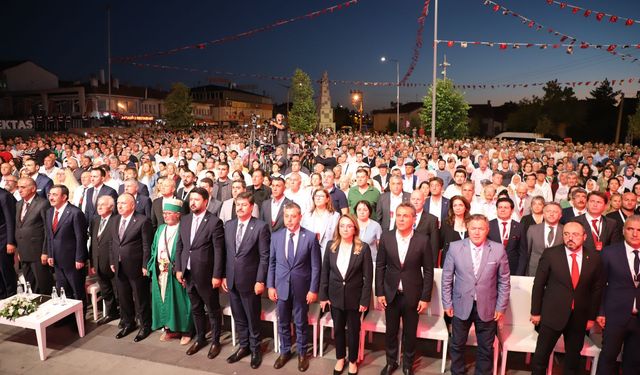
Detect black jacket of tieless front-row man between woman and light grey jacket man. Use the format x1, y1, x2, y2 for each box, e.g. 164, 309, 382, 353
375, 230, 433, 306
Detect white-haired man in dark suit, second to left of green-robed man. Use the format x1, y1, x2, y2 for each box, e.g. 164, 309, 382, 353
89, 195, 120, 325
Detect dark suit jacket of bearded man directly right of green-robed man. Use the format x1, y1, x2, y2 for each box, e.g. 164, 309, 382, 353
175, 211, 225, 288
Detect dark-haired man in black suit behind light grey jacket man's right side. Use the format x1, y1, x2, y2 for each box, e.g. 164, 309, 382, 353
489, 197, 528, 276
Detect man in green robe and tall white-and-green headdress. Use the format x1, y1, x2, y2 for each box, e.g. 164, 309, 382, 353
147, 198, 193, 345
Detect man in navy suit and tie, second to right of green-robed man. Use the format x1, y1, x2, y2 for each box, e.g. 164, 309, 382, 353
222, 192, 271, 369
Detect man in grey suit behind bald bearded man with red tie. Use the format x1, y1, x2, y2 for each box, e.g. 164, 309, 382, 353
526, 202, 563, 276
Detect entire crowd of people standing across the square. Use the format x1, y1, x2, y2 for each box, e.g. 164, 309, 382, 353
0, 121, 640, 375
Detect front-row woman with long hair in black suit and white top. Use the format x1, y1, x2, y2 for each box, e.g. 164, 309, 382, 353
320, 214, 373, 375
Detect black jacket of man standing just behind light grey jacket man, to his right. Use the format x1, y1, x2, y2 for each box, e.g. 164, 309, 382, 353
489, 219, 529, 276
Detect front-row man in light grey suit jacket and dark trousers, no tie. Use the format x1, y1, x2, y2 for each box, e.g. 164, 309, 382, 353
442, 215, 510, 375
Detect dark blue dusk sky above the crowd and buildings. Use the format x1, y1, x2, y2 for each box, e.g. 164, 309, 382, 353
0, 0, 640, 111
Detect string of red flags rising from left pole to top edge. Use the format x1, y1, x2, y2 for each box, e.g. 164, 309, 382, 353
111, 0, 360, 63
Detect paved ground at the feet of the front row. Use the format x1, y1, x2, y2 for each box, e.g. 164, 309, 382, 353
0, 318, 586, 375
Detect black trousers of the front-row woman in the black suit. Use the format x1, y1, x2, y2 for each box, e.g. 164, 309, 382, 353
331, 306, 360, 363
